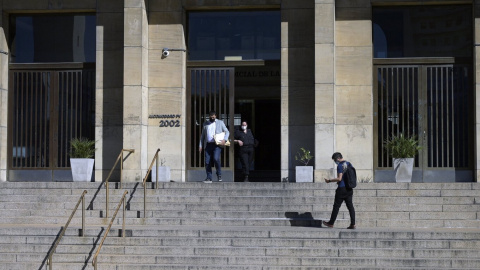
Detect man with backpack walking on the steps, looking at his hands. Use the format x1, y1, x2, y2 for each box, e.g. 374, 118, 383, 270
322, 152, 357, 229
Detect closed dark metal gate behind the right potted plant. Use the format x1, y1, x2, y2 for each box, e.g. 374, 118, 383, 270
374, 64, 474, 182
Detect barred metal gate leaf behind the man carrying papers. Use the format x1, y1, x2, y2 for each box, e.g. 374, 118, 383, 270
187, 68, 235, 182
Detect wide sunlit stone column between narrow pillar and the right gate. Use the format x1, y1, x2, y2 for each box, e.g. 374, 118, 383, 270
334, 0, 373, 180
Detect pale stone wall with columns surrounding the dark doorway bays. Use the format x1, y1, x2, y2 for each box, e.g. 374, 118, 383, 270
0, 0, 480, 181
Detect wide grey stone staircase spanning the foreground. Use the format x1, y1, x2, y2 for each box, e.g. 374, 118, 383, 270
0, 182, 480, 270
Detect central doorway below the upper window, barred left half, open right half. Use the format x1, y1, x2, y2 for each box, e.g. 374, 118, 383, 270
187, 61, 281, 182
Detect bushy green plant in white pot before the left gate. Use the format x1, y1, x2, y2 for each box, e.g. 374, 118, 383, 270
70, 138, 96, 182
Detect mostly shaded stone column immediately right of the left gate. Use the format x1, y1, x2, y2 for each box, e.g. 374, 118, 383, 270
95, 0, 124, 181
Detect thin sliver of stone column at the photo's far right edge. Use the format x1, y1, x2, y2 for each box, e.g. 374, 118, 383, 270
473, 0, 480, 182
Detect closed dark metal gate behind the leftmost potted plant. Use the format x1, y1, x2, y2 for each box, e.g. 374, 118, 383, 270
8, 64, 95, 181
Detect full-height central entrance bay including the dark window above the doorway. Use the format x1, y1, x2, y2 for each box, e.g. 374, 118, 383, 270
186, 10, 281, 181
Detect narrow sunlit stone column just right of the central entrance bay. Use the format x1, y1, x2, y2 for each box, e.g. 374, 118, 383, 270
314, 0, 335, 182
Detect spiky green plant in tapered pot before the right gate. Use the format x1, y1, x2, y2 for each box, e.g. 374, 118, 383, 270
384, 133, 421, 182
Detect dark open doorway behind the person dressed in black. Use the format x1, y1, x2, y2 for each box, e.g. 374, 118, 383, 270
234, 61, 281, 182
